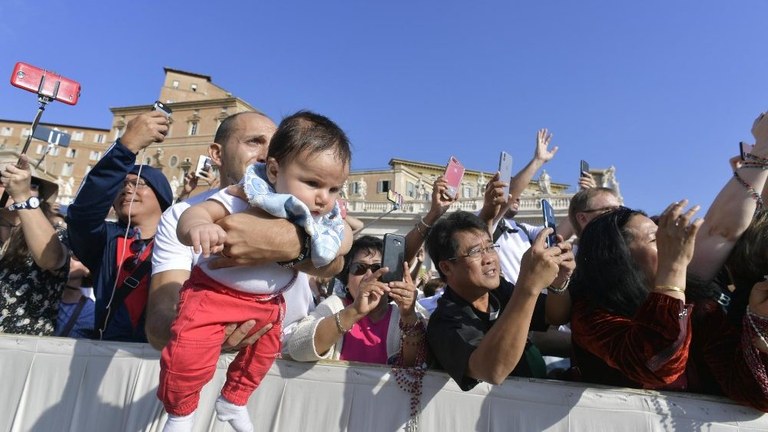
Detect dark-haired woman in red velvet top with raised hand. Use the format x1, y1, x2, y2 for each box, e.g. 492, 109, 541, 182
571, 201, 702, 390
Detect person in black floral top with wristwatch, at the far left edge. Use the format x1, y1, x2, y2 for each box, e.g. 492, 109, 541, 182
0, 156, 69, 336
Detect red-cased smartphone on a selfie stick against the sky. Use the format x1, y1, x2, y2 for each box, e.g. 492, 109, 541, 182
11, 62, 80, 105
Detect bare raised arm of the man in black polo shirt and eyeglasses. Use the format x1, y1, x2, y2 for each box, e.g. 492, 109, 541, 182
467, 228, 566, 384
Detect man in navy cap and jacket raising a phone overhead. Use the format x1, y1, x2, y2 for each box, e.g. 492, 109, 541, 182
67, 111, 173, 342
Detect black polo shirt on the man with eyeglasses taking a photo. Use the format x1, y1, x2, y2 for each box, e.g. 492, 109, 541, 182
427, 278, 548, 391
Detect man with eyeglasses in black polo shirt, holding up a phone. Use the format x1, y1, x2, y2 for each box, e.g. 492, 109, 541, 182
427, 211, 575, 391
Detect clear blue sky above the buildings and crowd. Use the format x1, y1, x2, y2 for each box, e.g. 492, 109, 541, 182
0, 0, 768, 213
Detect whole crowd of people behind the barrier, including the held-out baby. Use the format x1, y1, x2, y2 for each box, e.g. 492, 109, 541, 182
0, 106, 768, 431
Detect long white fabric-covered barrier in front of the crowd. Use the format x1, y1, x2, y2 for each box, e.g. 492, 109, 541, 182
0, 335, 768, 432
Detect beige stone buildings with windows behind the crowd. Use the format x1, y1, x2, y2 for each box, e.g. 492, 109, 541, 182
0, 68, 618, 235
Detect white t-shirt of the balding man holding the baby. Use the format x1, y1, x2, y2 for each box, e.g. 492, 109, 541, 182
152, 189, 315, 339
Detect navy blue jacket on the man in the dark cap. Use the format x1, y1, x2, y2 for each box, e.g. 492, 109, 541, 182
67, 140, 149, 342
